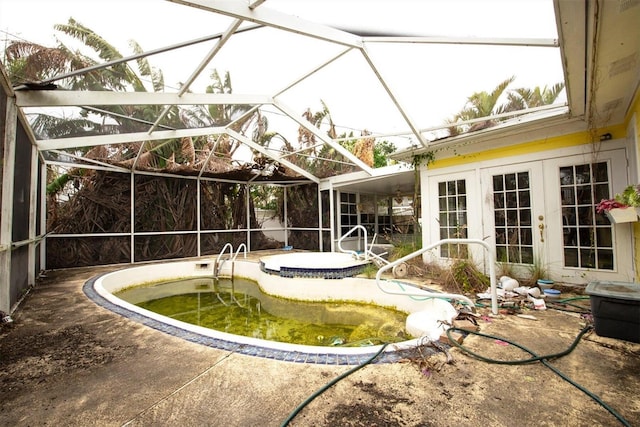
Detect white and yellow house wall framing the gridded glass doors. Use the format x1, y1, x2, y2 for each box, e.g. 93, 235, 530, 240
420, 89, 640, 284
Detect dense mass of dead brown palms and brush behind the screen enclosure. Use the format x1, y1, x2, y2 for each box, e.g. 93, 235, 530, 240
5, 18, 395, 268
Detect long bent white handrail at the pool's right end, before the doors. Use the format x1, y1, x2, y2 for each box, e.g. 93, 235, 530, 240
376, 239, 498, 314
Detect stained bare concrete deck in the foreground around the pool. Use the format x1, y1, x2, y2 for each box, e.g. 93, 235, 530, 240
0, 253, 640, 427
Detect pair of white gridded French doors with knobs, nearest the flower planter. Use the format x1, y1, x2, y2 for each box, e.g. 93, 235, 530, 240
481, 150, 634, 283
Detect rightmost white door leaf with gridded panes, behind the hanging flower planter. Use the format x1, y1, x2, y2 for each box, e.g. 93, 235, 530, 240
543, 149, 635, 284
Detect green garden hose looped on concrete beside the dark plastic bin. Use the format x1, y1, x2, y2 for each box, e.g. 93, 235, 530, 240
447, 325, 631, 427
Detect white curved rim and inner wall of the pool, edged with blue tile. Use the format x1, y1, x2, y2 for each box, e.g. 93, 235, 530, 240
83, 254, 457, 365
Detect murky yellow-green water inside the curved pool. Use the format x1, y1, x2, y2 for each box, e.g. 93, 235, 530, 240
115, 278, 407, 346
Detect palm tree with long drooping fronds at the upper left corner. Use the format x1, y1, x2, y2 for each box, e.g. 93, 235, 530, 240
5, 18, 179, 138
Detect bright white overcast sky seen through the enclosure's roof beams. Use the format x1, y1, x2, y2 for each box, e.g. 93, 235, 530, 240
0, 0, 563, 150
